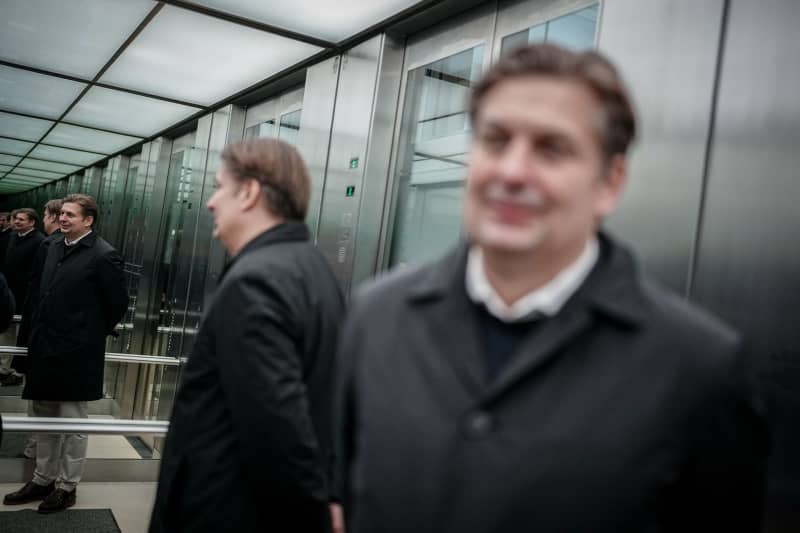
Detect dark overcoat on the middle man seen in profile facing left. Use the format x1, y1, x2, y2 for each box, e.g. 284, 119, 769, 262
150, 222, 344, 532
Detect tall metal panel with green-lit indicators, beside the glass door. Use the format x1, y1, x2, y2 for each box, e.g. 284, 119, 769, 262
317, 35, 383, 293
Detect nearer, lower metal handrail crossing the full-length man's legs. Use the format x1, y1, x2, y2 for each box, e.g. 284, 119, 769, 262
3, 416, 169, 437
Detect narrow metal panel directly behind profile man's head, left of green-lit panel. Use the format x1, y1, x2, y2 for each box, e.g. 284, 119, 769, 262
296, 56, 341, 242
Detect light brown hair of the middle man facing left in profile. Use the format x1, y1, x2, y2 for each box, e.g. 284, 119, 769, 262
222, 139, 311, 220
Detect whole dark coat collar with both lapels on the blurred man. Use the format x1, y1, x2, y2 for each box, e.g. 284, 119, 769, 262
408, 233, 648, 403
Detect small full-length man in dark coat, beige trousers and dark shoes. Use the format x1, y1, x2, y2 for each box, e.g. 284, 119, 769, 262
3, 194, 128, 513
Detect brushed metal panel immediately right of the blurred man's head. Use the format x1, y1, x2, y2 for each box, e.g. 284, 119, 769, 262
599, 0, 724, 293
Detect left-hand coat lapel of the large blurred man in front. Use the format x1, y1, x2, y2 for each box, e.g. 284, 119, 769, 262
411, 244, 486, 395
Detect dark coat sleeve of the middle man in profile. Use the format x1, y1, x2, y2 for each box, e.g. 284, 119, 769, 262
215, 276, 330, 531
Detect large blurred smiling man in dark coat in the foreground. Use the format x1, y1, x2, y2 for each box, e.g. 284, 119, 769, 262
332, 45, 766, 533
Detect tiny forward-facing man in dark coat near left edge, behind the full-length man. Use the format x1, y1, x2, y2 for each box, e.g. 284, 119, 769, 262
0, 208, 44, 386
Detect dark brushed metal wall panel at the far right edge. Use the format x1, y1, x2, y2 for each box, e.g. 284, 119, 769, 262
692, 0, 800, 532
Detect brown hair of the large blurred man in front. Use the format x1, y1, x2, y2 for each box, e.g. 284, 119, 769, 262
470, 44, 636, 159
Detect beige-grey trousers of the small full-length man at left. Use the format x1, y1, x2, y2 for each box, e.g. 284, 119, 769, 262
32, 400, 89, 491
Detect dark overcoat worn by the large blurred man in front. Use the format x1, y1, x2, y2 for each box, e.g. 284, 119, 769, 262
340, 237, 767, 533
